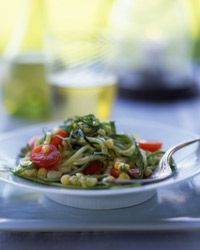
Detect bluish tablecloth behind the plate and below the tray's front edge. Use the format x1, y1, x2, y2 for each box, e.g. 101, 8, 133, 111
0, 92, 200, 250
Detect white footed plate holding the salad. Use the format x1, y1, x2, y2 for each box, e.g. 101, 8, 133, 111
0, 119, 199, 209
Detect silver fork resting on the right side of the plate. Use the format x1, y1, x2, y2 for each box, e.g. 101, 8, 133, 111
104, 138, 200, 185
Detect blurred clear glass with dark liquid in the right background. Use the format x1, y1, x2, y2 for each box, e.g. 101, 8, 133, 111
108, 0, 196, 101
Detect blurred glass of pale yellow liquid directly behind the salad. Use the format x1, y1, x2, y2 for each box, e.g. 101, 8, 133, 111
45, 0, 117, 119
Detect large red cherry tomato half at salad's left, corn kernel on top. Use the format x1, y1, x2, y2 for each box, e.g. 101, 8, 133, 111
30, 144, 61, 169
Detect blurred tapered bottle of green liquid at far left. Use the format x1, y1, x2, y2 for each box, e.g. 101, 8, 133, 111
3, 0, 51, 120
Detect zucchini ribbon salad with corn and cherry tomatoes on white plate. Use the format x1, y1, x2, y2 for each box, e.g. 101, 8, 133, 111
13, 114, 164, 189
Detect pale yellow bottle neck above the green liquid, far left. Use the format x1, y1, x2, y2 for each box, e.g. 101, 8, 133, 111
5, 0, 44, 57
